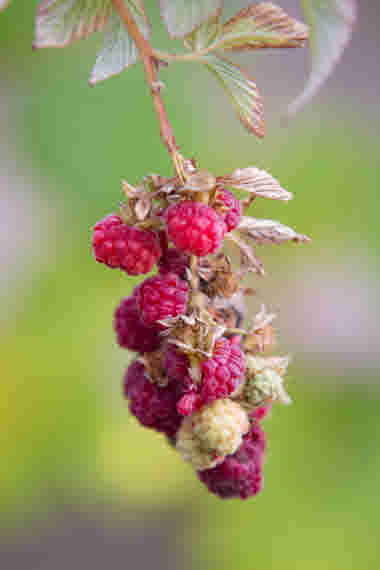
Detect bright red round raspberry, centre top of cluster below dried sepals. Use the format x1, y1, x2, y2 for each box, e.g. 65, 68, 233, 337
165, 200, 227, 257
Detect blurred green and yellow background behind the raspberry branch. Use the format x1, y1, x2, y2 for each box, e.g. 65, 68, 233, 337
0, 0, 380, 570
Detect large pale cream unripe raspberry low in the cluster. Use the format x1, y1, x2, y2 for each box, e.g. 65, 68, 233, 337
177, 399, 249, 470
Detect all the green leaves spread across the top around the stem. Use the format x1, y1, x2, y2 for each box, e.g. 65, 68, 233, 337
27, 0, 356, 137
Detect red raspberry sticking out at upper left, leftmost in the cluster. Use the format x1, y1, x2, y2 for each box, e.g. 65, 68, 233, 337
92, 214, 161, 275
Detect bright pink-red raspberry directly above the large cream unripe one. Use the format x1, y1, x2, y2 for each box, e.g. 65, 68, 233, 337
178, 338, 246, 415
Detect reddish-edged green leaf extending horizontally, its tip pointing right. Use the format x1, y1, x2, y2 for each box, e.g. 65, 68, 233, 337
217, 2, 308, 51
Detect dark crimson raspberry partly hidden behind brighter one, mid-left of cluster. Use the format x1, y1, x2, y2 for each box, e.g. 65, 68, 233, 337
113, 295, 161, 352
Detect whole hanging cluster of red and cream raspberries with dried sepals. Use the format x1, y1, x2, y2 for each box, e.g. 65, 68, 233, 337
92, 162, 300, 499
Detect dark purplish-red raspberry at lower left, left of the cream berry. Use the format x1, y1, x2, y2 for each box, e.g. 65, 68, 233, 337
124, 361, 182, 438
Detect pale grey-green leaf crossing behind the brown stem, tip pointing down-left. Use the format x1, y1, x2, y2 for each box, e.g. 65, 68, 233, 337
89, 0, 151, 85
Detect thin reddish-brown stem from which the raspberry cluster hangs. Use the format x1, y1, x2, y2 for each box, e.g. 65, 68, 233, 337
112, 0, 183, 179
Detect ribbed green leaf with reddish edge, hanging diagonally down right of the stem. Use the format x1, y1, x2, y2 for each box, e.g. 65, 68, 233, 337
203, 55, 264, 137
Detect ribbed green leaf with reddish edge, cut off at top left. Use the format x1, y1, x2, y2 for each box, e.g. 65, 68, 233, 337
33, 0, 112, 48
